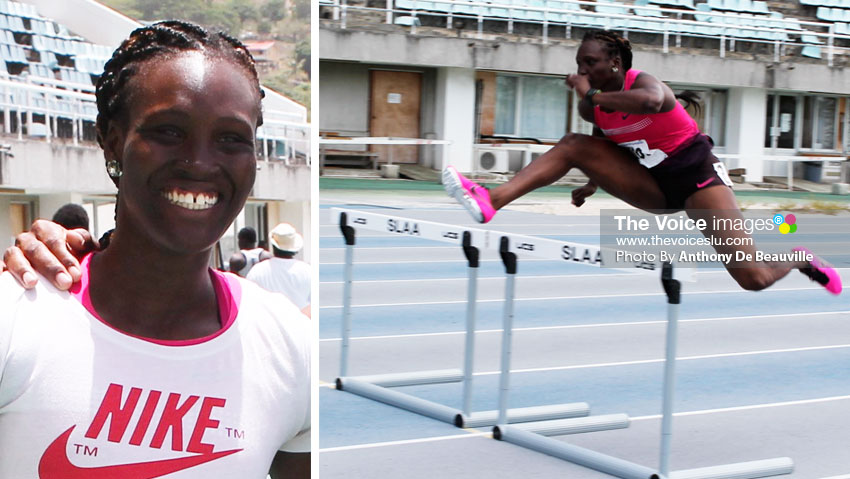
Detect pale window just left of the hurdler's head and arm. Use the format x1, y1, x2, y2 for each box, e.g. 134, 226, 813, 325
494, 74, 567, 140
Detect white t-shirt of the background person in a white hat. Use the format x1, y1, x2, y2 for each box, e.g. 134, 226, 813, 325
248, 258, 310, 309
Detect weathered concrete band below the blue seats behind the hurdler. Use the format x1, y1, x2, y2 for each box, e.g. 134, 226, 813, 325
319, 27, 850, 94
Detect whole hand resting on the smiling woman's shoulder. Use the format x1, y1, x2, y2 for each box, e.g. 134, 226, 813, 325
0, 220, 97, 290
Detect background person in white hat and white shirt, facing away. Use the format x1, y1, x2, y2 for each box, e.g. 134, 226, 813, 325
247, 223, 310, 310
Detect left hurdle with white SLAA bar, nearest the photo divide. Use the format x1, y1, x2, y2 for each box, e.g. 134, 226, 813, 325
331, 208, 625, 428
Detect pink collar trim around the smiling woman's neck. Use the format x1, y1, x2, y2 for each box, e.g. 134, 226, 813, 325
69, 253, 242, 346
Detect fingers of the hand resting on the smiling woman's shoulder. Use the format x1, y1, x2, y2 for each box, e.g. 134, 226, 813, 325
15, 230, 74, 290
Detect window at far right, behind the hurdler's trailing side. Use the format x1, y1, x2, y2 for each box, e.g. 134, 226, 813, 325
764, 95, 841, 151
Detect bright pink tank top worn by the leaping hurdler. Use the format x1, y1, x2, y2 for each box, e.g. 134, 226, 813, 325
593, 69, 699, 155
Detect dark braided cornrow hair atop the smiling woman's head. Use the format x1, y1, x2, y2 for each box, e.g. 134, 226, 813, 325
95, 20, 264, 147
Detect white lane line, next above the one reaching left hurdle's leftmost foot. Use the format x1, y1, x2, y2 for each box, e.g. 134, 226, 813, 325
319, 310, 850, 343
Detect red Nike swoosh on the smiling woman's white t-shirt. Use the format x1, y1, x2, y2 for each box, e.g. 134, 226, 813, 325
38, 426, 242, 479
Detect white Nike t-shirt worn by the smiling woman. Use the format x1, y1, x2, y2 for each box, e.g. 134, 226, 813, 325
0, 262, 310, 479
